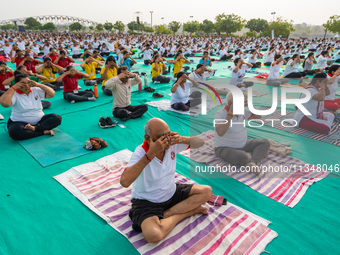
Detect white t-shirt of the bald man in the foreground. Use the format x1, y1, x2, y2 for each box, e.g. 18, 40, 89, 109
126, 141, 189, 203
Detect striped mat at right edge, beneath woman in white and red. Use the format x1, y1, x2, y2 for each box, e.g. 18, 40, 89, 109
263, 108, 340, 146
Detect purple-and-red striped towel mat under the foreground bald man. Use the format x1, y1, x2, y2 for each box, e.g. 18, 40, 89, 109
55, 150, 277, 255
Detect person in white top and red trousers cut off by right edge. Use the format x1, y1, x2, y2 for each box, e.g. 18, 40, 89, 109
325, 65, 340, 111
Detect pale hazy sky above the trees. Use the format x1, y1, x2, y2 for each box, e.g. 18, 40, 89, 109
0, 0, 339, 25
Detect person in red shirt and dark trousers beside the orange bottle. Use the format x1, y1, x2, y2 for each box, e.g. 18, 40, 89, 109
57, 66, 96, 104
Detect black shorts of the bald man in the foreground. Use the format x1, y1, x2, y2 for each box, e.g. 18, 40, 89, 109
129, 184, 193, 232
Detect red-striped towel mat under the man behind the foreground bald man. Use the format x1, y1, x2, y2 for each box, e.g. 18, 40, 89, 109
181, 130, 329, 208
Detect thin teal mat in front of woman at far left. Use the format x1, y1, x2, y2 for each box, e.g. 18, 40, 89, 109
17, 128, 92, 167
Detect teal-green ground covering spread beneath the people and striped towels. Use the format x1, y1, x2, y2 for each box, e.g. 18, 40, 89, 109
0, 52, 340, 255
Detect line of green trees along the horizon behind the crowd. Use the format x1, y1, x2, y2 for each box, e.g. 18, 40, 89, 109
1, 13, 340, 38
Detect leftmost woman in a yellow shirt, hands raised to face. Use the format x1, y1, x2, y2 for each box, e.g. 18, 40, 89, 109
36, 57, 65, 91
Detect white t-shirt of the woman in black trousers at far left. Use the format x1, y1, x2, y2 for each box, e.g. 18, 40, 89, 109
10, 87, 46, 125
